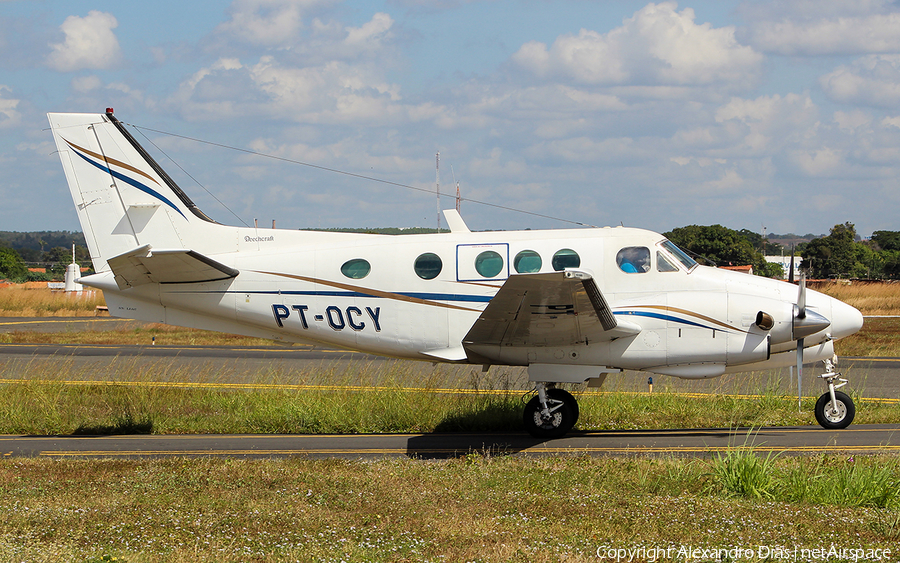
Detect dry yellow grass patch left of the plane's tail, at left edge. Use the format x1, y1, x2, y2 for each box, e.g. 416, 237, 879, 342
0, 286, 106, 317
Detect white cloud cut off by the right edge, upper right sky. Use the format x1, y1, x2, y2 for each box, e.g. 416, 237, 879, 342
819, 55, 900, 108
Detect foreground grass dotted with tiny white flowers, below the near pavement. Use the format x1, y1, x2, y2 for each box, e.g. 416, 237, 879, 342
0, 453, 900, 562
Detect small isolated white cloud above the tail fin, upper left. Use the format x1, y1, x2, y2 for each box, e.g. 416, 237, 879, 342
46, 10, 122, 72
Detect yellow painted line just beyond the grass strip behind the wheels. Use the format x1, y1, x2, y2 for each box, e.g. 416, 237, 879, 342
0, 379, 900, 404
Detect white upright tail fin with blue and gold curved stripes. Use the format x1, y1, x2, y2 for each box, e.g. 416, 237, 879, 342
47, 110, 218, 272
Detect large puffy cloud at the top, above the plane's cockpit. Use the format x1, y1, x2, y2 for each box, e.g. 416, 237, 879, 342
513, 2, 762, 86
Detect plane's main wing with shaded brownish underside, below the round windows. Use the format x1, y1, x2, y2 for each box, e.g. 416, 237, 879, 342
463, 270, 641, 349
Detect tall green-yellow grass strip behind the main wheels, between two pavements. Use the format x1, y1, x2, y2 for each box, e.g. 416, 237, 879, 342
0, 358, 900, 434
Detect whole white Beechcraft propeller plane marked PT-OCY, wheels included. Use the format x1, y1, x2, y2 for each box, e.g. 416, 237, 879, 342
48, 109, 863, 438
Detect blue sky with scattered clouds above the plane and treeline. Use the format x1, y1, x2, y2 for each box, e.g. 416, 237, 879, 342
0, 0, 900, 235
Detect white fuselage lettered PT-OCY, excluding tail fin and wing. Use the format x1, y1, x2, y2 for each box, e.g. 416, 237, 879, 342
88, 225, 862, 377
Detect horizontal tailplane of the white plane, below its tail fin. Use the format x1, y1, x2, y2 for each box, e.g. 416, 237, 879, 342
107, 244, 239, 289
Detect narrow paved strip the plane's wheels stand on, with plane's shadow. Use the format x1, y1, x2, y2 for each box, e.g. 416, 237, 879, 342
0, 425, 900, 459
